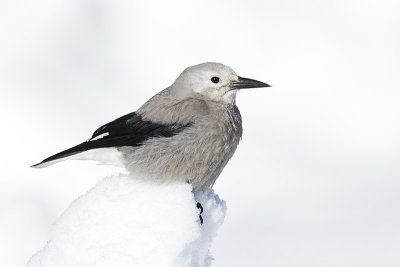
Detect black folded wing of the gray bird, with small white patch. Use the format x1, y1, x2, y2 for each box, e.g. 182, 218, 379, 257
32, 112, 190, 167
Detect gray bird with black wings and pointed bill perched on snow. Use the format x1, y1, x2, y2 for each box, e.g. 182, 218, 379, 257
32, 63, 270, 190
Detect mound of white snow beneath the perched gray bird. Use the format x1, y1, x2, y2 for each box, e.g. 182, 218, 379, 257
28, 174, 226, 267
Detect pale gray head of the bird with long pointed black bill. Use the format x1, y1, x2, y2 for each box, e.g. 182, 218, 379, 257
172, 62, 270, 104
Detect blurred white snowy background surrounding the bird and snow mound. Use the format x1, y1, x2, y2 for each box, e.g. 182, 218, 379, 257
0, 0, 400, 267
